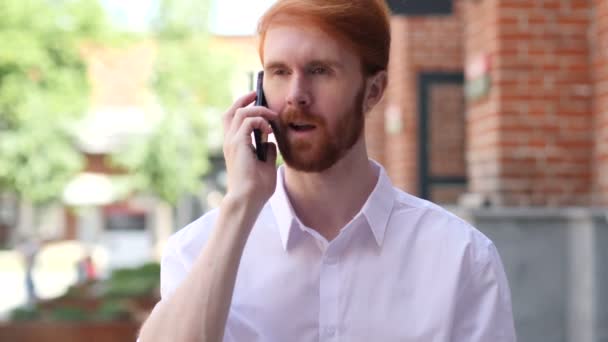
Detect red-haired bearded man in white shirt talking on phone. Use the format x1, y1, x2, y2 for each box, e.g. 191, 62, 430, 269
140, 0, 515, 342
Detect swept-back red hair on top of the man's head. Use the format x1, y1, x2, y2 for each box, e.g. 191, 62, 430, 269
258, 0, 391, 75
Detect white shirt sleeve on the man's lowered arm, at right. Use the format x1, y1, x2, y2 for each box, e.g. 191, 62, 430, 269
451, 244, 517, 342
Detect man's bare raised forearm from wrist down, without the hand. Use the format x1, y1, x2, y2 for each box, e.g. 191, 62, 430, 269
140, 198, 264, 342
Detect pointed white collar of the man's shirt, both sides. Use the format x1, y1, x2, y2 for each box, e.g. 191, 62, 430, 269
269, 160, 395, 250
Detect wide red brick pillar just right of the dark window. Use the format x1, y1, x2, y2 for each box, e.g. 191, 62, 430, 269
466, 0, 593, 206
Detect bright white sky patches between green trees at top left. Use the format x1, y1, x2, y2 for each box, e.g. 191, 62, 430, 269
101, 0, 275, 36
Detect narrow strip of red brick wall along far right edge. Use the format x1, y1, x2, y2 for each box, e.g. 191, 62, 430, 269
591, 0, 608, 206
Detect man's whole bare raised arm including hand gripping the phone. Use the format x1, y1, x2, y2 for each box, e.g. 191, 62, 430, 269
139, 93, 276, 342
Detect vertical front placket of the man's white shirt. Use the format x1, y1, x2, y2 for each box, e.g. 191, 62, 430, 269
319, 246, 340, 341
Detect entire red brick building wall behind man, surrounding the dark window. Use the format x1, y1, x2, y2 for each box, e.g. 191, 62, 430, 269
370, 0, 608, 205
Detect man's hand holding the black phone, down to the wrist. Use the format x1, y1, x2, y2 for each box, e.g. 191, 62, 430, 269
224, 92, 277, 206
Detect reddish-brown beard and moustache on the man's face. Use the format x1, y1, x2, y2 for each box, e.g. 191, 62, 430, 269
275, 87, 365, 172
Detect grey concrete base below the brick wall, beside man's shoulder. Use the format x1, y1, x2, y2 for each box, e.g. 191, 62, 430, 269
447, 207, 608, 342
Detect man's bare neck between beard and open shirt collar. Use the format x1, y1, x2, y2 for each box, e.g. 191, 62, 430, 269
285, 141, 378, 241
